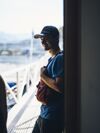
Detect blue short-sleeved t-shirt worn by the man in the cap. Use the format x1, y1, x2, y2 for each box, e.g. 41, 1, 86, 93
40, 52, 64, 120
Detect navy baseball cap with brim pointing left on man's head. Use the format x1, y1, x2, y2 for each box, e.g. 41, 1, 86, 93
34, 26, 59, 39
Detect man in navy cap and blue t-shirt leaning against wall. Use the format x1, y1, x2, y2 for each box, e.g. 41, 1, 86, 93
32, 26, 64, 133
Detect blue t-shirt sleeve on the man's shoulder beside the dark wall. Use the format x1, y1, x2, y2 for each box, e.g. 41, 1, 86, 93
52, 54, 64, 78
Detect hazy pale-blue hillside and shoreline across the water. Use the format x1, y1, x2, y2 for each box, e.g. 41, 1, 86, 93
0, 32, 43, 55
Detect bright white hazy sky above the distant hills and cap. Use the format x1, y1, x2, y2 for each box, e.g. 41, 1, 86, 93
0, 0, 63, 33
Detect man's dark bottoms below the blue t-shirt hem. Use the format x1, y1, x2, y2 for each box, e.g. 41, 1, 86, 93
32, 116, 63, 133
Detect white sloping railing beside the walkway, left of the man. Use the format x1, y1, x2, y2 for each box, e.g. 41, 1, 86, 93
1, 54, 49, 129
